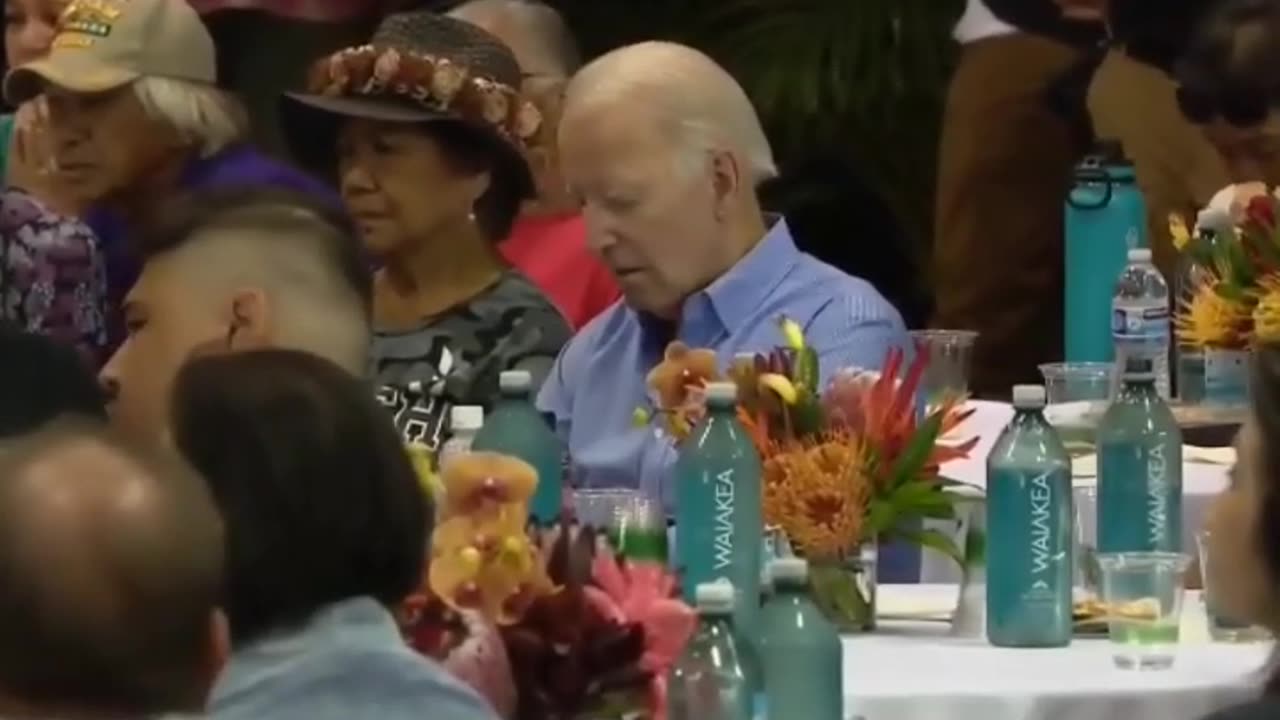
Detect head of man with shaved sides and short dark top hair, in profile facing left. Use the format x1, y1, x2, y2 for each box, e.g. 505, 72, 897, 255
101, 187, 370, 438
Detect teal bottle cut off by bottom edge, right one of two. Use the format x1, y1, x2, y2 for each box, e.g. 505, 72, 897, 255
759, 557, 845, 720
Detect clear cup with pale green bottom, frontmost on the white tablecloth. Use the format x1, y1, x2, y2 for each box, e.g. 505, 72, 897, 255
1098, 552, 1190, 670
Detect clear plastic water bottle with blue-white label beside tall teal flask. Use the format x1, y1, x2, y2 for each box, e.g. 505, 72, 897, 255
1111, 247, 1170, 400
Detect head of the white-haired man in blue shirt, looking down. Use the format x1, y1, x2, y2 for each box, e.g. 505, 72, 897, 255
559, 42, 777, 316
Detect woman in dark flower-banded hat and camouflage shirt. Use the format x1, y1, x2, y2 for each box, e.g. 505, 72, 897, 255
283, 12, 571, 447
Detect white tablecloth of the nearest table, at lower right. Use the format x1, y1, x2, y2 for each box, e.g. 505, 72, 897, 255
844, 585, 1270, 720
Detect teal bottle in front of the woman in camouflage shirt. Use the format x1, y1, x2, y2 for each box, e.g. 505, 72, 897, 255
471, 370, 564, 524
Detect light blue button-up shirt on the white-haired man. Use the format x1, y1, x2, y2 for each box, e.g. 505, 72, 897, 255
538, 220, 910, 507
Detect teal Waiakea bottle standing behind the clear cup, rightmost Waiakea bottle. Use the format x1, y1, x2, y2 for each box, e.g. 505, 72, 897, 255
1098, 357, 1183, 552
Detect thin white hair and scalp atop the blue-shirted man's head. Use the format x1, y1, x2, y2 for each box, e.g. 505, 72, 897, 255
564, 41, 778, 186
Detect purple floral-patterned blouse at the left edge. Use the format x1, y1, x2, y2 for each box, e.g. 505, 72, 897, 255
0, 188, 106, 366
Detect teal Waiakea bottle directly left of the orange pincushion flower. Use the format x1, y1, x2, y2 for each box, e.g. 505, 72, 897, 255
676, 383, 764, 637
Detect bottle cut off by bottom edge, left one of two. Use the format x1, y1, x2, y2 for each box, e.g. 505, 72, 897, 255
667, 582, 760, 720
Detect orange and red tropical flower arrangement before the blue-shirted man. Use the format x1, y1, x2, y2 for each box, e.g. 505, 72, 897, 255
637, 319, 978, 630
